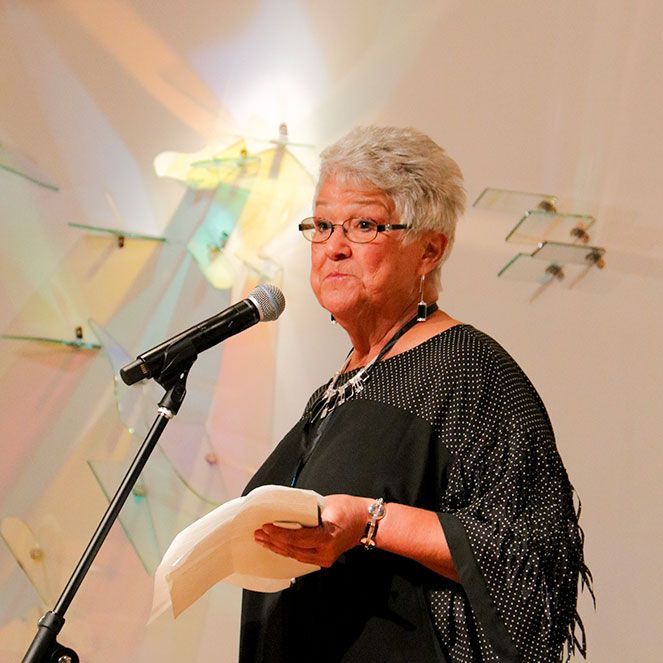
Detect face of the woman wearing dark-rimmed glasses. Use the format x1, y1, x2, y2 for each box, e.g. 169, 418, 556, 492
311, 177, 425, 321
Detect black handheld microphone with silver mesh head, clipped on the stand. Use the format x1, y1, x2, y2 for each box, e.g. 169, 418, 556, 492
120, 283, 285, 385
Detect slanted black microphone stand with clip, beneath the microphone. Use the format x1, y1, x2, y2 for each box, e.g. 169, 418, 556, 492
23, 340, 198, 663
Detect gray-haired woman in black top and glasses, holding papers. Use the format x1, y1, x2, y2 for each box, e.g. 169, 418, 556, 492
240, 127, 587, 663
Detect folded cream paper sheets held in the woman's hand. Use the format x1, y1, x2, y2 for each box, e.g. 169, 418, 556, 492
151, 486, 324, 620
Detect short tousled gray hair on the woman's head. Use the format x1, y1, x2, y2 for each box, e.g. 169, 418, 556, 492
316, 126, 465, 279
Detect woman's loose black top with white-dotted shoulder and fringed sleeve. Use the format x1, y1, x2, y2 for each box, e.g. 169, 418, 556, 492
240, 325, 591, 663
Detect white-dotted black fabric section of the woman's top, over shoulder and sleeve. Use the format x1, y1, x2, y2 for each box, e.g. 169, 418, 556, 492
320, 325, 591, 663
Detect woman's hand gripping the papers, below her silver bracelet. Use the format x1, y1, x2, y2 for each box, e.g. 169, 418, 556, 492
254, 495, 373, 567
